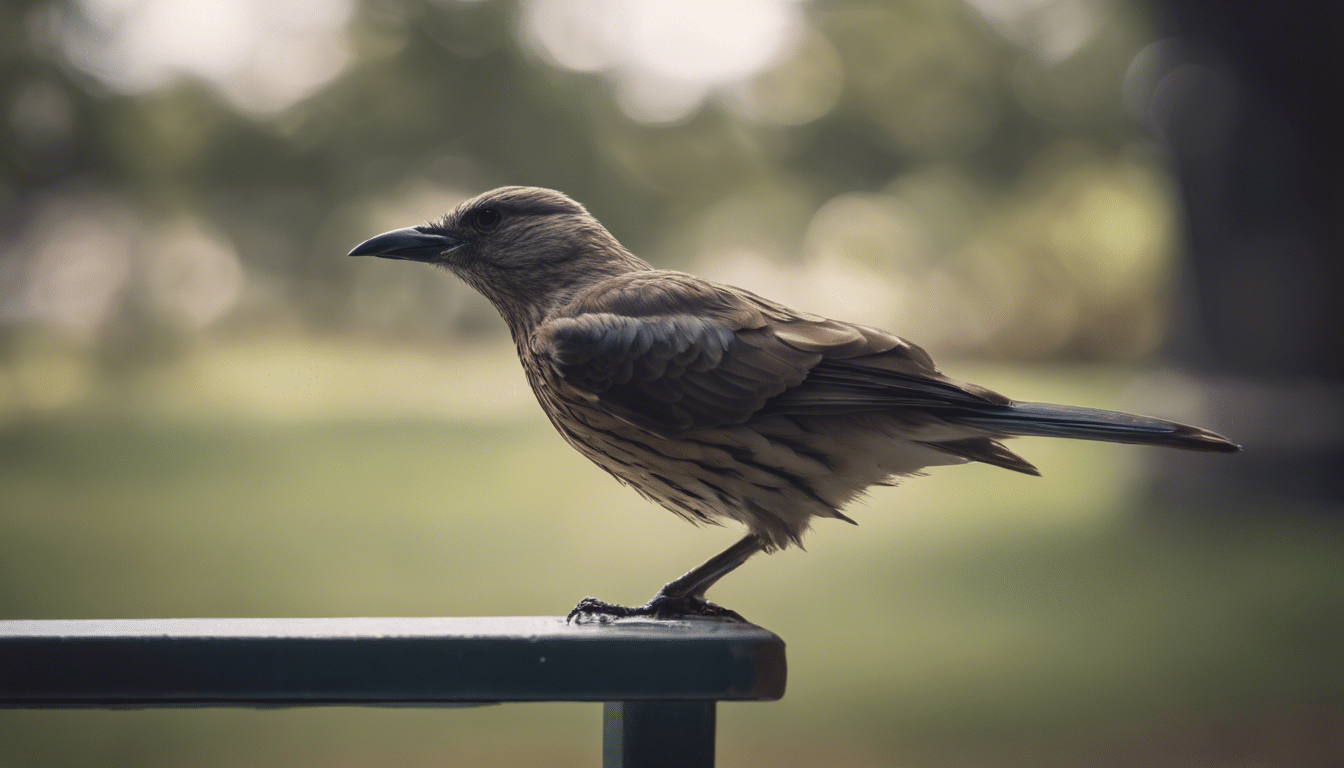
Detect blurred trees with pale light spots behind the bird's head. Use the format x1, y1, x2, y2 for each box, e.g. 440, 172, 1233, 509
0, 0, 1173, 360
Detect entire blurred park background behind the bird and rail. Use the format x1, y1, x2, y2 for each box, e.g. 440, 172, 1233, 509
0, 0, 1344, 767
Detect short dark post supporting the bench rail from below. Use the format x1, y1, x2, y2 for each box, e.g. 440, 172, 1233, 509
602, 701, 716, 768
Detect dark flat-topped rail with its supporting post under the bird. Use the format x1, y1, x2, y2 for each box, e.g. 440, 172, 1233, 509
0, 616, 785, 768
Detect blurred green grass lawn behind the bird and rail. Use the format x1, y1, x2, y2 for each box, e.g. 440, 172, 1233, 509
0, 343, 1344, 767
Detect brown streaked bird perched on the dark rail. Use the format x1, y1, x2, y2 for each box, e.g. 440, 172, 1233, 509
349, 187, 1241, 621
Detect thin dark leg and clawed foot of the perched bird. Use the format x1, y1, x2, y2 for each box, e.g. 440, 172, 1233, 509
567, 534, 765, 621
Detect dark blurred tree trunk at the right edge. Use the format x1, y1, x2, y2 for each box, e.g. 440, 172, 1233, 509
1136, 0, 1344, 515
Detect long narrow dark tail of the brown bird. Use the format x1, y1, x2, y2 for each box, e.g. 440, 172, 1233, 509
945, 402, 1242, 453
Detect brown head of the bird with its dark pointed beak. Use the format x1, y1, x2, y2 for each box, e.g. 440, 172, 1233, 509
349, 187, 649, 332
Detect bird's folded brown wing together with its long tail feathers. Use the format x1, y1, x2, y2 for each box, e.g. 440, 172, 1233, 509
524, 270, 1236, 484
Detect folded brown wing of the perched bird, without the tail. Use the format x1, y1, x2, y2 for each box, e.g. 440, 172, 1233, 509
531, 270, 1008, 434
